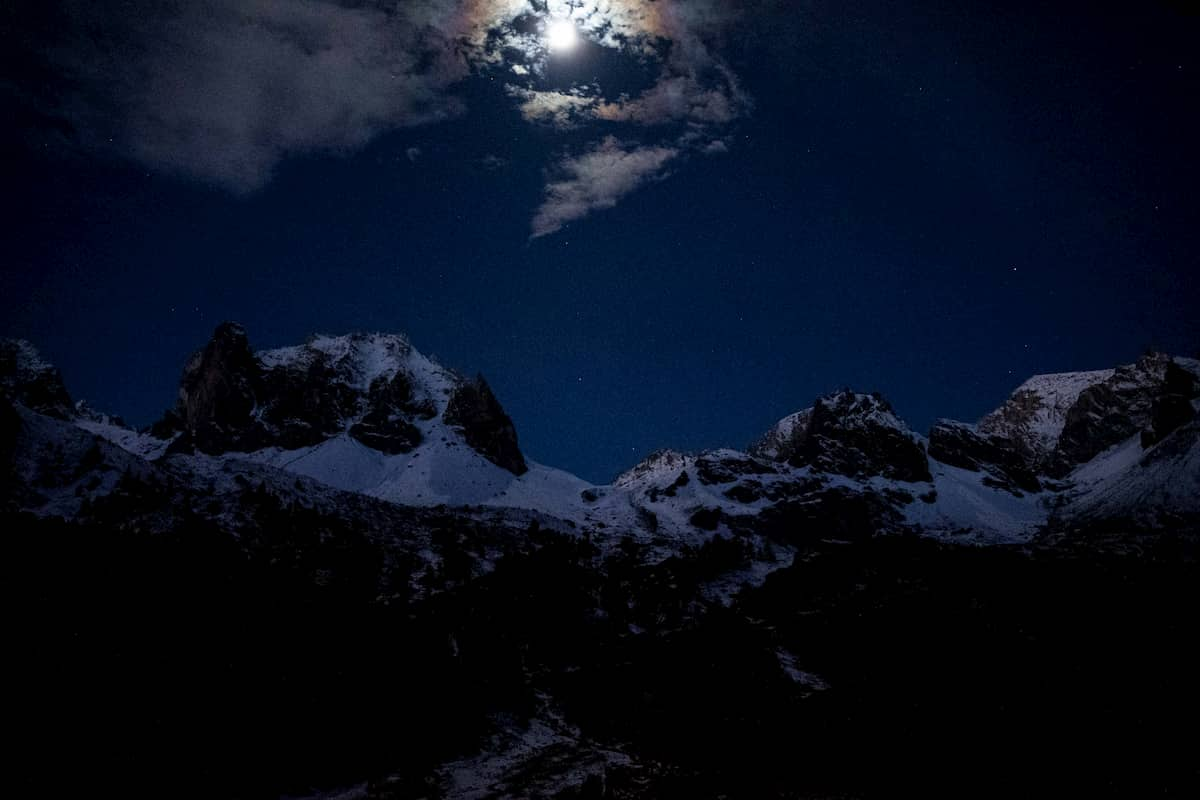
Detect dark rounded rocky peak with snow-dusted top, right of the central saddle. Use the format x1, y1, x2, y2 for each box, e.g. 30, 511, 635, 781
751, 390, 931, 481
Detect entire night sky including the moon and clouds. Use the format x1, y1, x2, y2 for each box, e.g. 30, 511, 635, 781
0, 0, 1200, 481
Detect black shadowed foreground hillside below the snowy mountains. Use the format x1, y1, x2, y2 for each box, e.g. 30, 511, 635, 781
2, 511, 1200, 798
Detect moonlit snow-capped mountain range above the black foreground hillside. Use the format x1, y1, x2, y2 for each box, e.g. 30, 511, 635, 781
0, 324, 1200, 555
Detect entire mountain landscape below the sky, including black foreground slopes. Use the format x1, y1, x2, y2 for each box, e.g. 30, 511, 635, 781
0, 325, 1200, 800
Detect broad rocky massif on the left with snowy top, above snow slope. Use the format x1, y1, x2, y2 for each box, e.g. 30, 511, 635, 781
154, 323, 527, 474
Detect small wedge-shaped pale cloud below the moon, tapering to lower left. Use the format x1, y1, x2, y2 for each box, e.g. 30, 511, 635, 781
532, 137, 679, 239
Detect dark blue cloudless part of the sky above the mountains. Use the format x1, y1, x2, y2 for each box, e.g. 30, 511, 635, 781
0, 1, 1200, 480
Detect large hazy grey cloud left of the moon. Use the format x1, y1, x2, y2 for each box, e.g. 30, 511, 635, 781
19, 0, 467, 192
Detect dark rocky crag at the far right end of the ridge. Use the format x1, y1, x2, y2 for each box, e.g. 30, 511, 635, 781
1046, 353, 1196, 475
